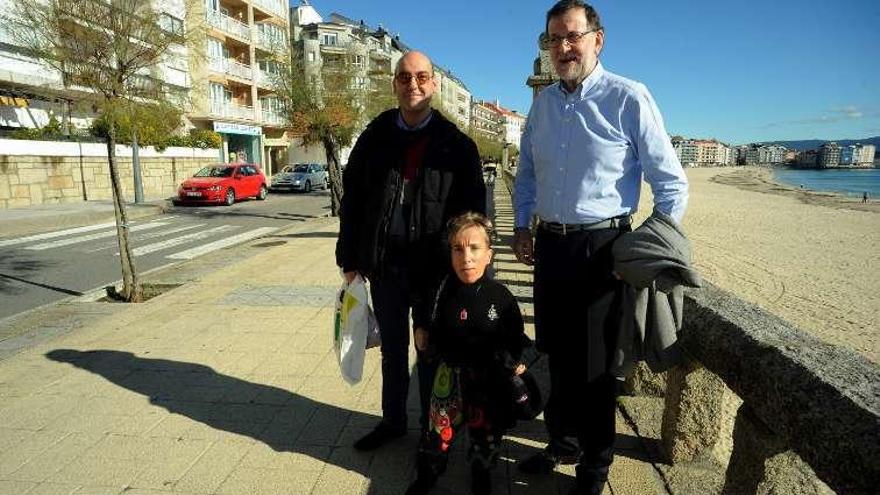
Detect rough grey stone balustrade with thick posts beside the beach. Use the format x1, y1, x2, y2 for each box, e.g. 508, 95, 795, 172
631, 282, 880, 494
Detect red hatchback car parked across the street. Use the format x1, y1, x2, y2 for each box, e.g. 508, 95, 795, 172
177, 163, 269, 205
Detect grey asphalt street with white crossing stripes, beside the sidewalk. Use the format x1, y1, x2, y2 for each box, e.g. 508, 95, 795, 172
0, 191, 330, 319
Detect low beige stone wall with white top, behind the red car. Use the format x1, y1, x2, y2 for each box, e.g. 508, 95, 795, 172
0, 139, 219, 209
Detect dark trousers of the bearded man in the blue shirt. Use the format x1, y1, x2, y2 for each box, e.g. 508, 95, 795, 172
534, 223, 629, 481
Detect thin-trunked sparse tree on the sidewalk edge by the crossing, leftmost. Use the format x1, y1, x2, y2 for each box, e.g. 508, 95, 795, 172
3, 0, 197, 302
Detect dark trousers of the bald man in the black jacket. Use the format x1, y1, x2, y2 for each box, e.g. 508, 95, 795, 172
370, 265, 433, 429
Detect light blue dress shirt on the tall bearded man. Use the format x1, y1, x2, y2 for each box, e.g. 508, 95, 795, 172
514, 62, 688, 227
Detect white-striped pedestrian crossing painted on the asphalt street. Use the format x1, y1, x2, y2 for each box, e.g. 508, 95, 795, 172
0, 216, 278, 260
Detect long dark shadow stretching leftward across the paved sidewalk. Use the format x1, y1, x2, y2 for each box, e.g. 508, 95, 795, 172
46, 349, 651, 494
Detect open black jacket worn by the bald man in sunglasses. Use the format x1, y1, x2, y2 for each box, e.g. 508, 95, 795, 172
336, 109, 486, 326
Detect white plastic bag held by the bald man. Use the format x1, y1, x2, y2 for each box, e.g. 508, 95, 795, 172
333, 274, 379, 385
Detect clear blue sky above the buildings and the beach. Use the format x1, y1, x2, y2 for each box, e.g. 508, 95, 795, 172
298, 0, 880, 144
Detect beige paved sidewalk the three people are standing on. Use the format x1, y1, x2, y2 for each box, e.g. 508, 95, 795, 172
0, 184, 665, 495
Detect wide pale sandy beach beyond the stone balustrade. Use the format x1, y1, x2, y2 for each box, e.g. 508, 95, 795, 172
639, 168, 880, 363
